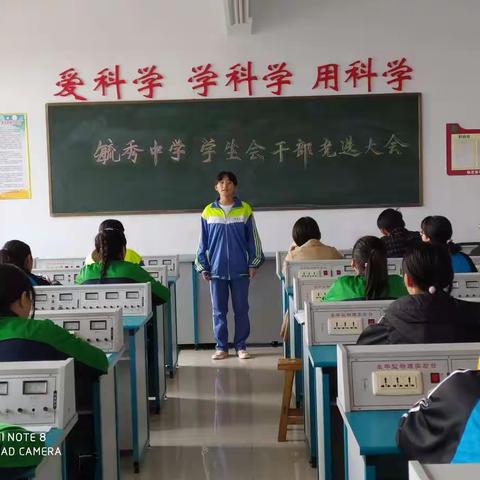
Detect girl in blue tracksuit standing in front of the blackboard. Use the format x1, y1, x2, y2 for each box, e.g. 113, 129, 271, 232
195, 172, 264, 360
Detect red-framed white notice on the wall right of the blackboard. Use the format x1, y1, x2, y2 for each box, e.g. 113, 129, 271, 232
447, 123, 480, 175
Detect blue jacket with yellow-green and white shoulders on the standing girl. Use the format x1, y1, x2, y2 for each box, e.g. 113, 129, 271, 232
195, 197, 265, 280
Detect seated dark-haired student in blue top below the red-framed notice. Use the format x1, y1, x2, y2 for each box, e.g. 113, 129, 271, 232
422, 215, 477, 273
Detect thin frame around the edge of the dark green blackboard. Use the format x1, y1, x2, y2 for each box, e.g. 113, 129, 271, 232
45, 92, 423, 217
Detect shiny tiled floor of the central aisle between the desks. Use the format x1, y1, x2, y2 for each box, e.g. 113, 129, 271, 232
122, 348, 316, 480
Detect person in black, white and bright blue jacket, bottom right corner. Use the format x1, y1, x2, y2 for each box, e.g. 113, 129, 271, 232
397, 370, 480, 464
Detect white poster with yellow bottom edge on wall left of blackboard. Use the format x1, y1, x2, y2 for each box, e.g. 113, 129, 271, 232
0, 113, 32, 199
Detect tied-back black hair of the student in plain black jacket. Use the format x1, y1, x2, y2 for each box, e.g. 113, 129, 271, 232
403, 243, 454, 293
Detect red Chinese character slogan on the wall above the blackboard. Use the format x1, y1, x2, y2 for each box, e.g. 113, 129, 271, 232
54, 57, 413, 101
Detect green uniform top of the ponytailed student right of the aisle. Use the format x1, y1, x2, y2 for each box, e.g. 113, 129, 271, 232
322, 275, 408, 302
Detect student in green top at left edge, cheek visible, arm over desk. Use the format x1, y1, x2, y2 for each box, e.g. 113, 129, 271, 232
0, 264, 108, 478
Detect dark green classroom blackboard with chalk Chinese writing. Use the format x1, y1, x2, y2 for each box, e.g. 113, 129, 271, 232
47, 94, 421, 215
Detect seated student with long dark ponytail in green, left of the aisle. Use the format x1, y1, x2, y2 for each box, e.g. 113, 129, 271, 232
75, 229, 170, 305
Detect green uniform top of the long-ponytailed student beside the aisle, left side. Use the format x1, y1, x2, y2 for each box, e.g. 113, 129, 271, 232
75, 260, 170, 305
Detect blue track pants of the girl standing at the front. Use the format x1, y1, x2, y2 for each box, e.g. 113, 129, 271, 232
210, 277, 250, 351
